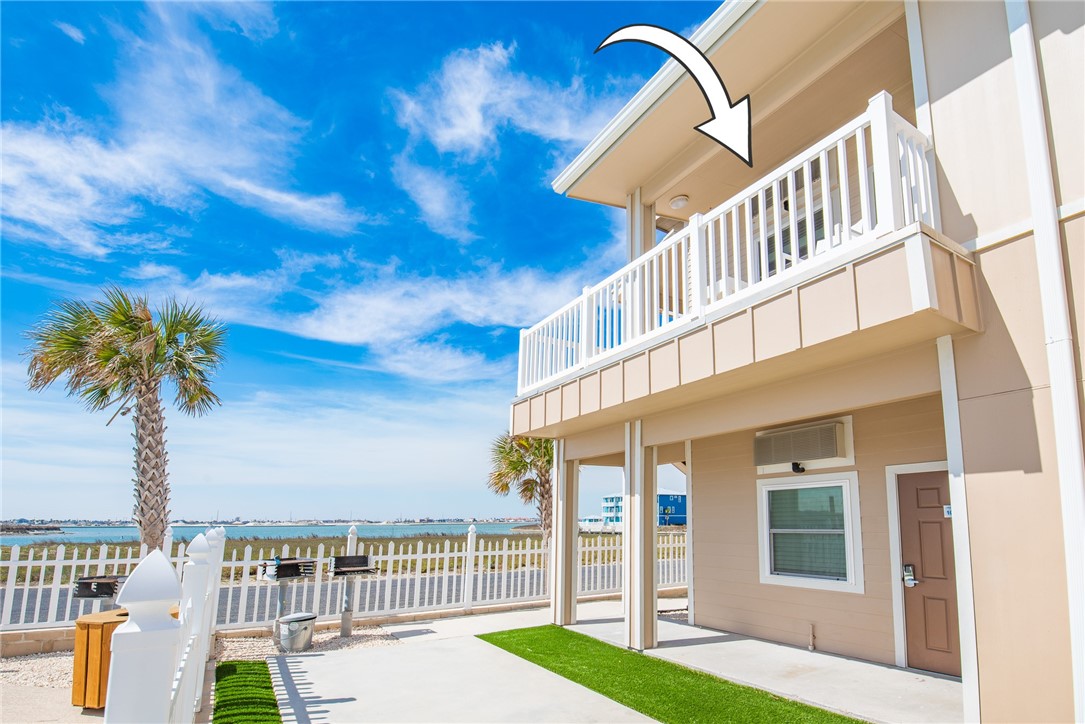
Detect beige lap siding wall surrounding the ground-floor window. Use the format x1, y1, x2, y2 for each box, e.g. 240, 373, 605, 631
692, 395, 945, 664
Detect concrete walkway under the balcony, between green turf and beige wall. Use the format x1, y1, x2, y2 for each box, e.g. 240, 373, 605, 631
571, 606, 963, 724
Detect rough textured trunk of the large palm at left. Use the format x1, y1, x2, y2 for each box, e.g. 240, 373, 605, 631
132, 382, 169, 549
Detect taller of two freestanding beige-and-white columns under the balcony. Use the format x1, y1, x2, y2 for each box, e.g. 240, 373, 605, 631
622, 420, 659, 651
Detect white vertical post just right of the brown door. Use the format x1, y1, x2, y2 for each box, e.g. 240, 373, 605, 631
941, 335, 980, 722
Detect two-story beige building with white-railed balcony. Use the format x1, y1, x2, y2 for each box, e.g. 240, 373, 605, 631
511, 0, 1085, 722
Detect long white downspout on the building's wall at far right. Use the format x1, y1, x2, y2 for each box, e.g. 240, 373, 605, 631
1006, 0, 1085, 722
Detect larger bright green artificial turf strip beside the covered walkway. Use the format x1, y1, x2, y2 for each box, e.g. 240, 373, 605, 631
478, 625, 855, 724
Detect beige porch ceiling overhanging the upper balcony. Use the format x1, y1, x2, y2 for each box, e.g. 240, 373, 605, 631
566, 1, 914, 218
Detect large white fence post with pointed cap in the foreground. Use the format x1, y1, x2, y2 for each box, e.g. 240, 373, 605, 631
105, 550, 180, 724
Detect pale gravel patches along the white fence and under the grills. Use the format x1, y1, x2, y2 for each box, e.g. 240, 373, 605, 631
0, 626, 399, 689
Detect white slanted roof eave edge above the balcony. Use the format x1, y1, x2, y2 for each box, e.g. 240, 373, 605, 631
551, 0, 765, 198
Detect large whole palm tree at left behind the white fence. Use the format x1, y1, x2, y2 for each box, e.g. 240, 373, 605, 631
26, 287, 226, 549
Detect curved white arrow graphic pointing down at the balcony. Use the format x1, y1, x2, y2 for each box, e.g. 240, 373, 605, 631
596, 25, 753, 168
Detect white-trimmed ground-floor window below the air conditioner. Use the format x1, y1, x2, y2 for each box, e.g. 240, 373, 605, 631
757, 472, 864, 594
